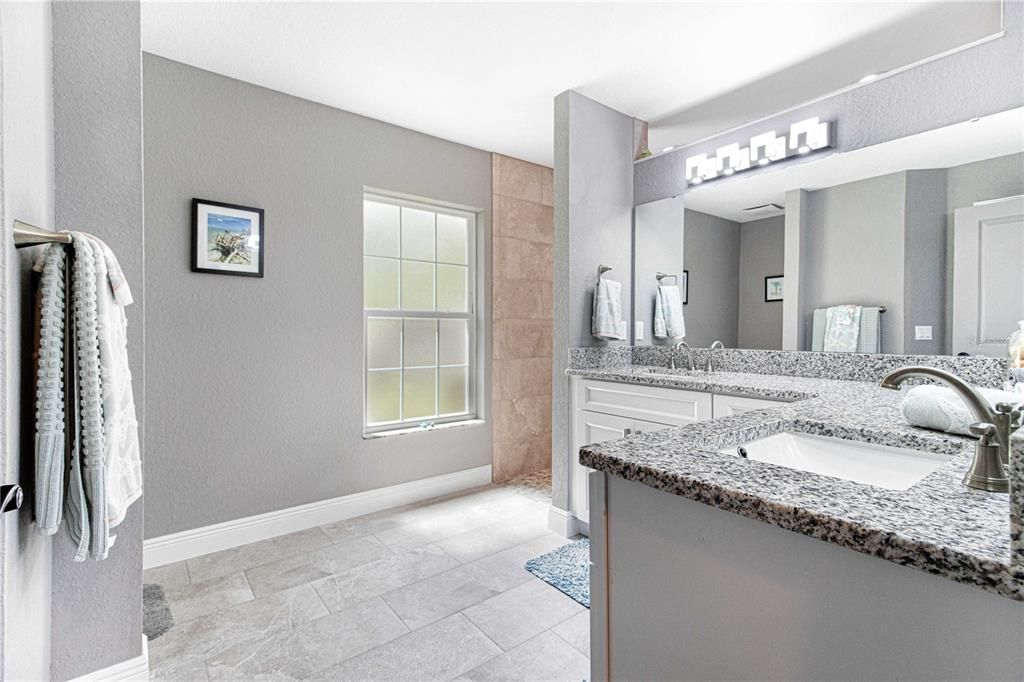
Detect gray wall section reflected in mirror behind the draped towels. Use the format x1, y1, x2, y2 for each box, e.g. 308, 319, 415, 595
801, 173, 906, 353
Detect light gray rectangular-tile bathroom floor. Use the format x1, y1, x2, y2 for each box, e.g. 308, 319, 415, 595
145, 479, 590, 682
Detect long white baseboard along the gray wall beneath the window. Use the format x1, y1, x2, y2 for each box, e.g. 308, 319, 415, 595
142, 464, 490, 568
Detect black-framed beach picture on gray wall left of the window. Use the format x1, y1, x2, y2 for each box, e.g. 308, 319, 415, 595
191, 197, 266, 278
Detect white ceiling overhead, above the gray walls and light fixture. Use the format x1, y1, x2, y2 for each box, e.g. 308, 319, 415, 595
142, 0, 995, 165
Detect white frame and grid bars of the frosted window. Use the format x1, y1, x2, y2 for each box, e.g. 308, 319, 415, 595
362, 194, 476, 433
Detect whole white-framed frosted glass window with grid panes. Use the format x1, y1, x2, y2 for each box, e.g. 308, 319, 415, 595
364, 193, 477, 433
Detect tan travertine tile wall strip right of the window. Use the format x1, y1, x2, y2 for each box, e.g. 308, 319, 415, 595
492, 154, 554, 482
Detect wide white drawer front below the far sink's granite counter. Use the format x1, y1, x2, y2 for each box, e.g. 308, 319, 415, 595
575, 379, 712, 426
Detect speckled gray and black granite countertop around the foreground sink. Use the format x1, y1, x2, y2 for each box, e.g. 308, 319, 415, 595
567, 366, 1024, 601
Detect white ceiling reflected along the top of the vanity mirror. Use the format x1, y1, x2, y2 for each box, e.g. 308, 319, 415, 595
683, 109, 1024, 222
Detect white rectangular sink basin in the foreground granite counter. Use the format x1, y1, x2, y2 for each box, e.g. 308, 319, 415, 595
721, 431, 949, 491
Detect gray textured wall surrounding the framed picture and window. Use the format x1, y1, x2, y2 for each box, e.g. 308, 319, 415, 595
143, 54, 490, 538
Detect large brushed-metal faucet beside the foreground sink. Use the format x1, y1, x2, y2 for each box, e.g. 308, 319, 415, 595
882, 367, 1021, 493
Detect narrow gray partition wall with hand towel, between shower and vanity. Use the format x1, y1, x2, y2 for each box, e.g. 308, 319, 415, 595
551, 90, 634, 509
